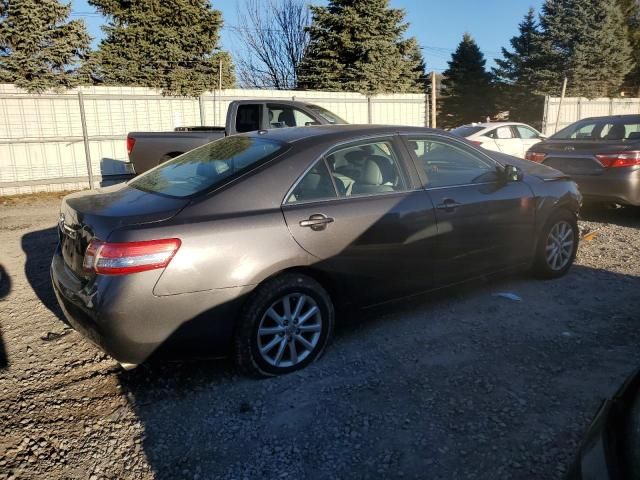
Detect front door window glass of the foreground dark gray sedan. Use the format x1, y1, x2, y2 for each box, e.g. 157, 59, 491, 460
408, 138, 495, 187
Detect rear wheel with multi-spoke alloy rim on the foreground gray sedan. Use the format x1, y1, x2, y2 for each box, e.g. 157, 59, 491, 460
235, 274, 335, 377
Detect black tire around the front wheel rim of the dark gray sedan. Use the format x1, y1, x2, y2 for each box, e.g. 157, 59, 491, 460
533, 209, 580, 279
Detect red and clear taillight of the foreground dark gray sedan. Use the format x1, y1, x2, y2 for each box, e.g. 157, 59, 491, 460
82, 238, 181, 275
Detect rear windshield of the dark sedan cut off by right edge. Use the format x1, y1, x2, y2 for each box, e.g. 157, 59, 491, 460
551, 118, 640, 141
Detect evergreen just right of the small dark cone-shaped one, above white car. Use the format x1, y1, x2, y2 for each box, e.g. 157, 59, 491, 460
493, 8, 544, 124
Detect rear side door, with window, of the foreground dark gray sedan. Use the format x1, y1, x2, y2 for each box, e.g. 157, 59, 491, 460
283, 137, 436, 304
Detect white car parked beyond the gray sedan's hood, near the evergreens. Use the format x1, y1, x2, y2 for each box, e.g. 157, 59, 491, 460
451, 122, 545, 158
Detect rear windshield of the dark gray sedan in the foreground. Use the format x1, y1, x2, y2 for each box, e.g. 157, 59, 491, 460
129, 136, 284, 198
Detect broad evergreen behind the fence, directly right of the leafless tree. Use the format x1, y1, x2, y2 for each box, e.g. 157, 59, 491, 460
298, 0, 424, 94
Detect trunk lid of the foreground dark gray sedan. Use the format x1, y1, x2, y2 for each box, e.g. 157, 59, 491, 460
58, 184, 189, 280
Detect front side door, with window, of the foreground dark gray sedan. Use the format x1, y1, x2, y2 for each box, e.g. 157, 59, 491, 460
405, 135, 535, 285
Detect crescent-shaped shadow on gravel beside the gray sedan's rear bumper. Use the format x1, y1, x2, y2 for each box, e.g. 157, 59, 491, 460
21, 227, 64, 320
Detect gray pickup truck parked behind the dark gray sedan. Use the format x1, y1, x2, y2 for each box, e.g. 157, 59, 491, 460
127, 100, 347, 174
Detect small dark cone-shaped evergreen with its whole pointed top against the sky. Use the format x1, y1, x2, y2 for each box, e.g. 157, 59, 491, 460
440, 33, 494, 127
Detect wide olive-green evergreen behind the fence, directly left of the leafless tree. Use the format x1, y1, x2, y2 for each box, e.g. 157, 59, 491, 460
89, 0, 235, 96
